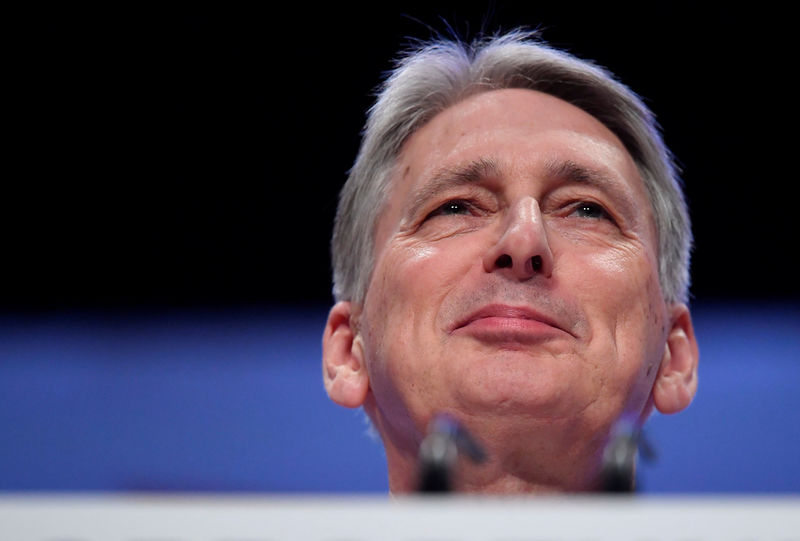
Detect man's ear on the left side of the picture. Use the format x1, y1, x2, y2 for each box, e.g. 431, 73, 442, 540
322, 301, 369, 408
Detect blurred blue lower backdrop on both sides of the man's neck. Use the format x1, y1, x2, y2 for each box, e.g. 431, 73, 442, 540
0, 302, 800, 492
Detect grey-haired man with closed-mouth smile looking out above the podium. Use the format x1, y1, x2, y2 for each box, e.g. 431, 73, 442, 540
323, 33, 698, 493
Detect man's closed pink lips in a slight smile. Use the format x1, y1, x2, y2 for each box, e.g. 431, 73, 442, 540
451, 304, 572, 342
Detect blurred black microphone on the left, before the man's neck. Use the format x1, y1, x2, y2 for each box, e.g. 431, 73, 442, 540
417, 413, 486, 493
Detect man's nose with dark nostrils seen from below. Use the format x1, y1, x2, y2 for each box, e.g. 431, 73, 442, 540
483, 197, 553, 280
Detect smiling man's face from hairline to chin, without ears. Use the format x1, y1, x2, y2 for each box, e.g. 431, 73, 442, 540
357, 89, 668, 464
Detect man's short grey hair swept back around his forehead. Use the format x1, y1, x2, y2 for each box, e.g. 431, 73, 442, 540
331, 31, 692, 304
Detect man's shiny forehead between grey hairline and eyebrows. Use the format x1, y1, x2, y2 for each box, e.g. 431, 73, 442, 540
404, 89, 641, 188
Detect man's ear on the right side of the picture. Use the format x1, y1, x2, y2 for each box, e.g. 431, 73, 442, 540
653, 303, 700, 414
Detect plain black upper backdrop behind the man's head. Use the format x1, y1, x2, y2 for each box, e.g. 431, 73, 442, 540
7, 2, 800, 312
